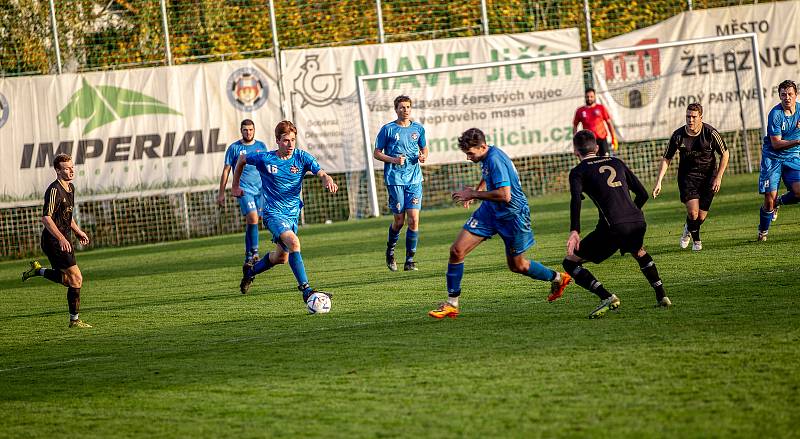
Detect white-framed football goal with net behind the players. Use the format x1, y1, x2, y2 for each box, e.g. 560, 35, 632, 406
355, 35, 763, 215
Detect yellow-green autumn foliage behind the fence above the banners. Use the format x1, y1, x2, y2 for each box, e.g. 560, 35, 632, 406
0, 0, 780, 75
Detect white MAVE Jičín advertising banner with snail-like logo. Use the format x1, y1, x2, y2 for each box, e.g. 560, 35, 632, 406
282, 28, 583, 171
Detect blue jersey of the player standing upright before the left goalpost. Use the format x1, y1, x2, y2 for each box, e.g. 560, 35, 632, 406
375, 121, 427, 186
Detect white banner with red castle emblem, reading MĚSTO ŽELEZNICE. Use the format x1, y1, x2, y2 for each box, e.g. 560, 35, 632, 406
593, 1, 800, 141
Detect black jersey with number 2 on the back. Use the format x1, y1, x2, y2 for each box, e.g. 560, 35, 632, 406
569, 156, 647, 232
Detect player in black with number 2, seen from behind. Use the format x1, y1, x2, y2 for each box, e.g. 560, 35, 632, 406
563, 130, 672, 318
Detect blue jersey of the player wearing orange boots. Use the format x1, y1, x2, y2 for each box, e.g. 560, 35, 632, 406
481, 145, 530, 219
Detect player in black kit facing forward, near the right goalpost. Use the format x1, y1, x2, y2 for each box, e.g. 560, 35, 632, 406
653, 103, 728, 251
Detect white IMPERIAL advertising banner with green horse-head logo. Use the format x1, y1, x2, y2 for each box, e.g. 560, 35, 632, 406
0, 58, 281, 203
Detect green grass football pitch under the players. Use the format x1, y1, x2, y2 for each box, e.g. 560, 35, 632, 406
0, 175, 800, 438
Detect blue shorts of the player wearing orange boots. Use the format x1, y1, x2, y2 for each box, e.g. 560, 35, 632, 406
464, 203, 536, 256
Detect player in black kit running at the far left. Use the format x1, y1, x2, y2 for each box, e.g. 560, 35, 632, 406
22, 154, 91, 328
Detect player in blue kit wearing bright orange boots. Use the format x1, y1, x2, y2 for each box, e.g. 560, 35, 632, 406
428, 128, 571, 319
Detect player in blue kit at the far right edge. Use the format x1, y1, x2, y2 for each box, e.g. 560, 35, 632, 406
758, 80, 800, 241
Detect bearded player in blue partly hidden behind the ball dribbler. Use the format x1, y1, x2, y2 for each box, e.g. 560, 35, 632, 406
217, 119, 267, 263
